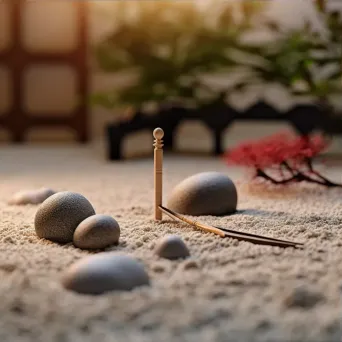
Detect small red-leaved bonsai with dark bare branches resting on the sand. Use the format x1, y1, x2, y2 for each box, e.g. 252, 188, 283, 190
225, 133, 342, 187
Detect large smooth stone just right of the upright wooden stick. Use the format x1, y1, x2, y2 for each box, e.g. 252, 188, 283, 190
168, 172, 237, 216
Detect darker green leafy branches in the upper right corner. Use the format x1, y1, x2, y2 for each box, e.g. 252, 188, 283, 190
234, 6, 342, 101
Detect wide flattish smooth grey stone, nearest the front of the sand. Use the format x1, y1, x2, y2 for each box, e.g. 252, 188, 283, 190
62, 252, 150, 295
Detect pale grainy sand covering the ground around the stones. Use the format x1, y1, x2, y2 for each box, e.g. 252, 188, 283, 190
0, 147, 342, 342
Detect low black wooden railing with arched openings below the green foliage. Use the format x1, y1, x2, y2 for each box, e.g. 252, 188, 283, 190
106, 101, 342, 160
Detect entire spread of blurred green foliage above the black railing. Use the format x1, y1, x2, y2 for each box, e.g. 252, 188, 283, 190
92, 0, 342, 109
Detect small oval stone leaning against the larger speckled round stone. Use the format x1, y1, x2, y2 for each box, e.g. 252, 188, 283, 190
73, 215, 120, 249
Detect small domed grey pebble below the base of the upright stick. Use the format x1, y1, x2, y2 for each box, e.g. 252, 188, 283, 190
155, 235, 190, 259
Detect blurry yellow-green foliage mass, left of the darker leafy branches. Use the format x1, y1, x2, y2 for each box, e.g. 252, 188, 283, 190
92, 1, 260, 108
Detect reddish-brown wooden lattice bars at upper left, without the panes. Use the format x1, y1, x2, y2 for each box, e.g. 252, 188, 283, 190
0, 0, 89, 143
